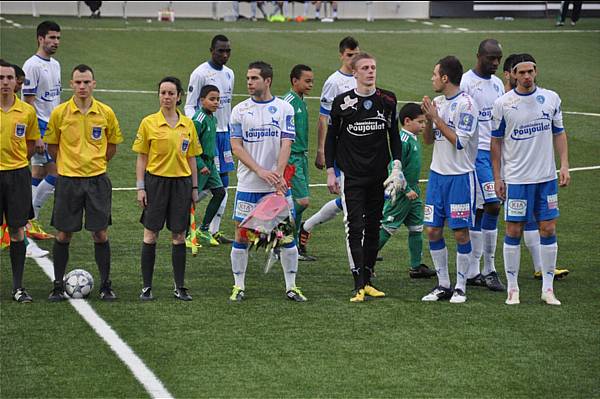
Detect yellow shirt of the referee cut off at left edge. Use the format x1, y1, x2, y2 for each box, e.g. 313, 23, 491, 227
0, 96, 40, 170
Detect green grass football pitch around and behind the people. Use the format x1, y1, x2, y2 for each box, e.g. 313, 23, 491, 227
0, 16, 600, 398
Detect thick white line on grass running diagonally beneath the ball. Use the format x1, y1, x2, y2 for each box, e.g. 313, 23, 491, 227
33, 257, 173, 398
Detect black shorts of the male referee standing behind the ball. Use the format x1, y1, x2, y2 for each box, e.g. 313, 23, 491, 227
50, 173, 112, 233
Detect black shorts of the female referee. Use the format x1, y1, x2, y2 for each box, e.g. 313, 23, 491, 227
140, 172, 192, 233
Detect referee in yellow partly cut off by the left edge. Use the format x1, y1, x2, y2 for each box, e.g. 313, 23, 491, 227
0, 60, 40, 303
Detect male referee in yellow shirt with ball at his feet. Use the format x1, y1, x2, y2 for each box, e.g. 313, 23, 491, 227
44, 64, 123, 302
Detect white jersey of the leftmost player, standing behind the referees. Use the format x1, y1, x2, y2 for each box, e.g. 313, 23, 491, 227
22, 54, 61, 124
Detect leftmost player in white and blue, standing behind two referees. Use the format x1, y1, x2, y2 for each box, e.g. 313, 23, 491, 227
23, 21, 61, 239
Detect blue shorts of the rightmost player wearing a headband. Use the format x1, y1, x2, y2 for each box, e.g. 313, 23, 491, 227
504, 179, 560, 223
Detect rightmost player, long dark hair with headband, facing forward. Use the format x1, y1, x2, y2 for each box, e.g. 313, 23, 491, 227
491, 54, 571, 305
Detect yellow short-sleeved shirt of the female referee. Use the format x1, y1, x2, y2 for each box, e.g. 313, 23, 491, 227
132, 111, 202, 177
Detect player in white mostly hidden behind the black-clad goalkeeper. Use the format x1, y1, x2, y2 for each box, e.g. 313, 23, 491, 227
298, 36, 360, 259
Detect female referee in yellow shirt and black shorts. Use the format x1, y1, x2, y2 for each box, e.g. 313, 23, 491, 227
133, 76, 202, 301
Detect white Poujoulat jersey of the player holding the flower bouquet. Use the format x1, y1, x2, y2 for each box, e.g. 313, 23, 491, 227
230, 97, 296, 193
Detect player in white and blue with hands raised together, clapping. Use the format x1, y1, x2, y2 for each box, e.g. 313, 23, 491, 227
422, 56, 478, 303
